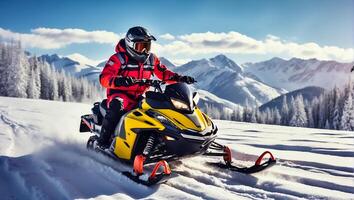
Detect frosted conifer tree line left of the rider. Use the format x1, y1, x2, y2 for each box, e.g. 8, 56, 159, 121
0, 41, 104, 102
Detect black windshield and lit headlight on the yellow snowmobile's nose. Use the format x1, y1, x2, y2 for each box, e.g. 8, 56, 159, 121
165, 83, 194, 113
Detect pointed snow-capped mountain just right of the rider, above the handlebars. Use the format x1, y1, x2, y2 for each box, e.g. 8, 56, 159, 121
176, 55, 284, 105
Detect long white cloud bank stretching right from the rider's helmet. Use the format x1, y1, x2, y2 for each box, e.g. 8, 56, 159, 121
156, 31, 354, 62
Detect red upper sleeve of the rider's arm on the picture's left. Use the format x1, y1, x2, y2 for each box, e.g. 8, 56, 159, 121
100, 55, 122, 89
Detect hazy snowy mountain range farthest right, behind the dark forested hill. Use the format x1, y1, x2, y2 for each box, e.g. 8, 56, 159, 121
242, 57, 354, 91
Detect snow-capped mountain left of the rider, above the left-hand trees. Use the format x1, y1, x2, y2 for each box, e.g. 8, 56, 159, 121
40, 54, 102, 81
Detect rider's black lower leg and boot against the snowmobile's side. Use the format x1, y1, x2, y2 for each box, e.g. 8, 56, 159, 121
97, 99, 124, 149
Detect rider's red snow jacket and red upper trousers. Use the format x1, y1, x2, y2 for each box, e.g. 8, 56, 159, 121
100, 39, 175, 110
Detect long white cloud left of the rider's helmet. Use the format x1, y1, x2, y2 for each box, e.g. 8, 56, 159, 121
0, 28, 120, 49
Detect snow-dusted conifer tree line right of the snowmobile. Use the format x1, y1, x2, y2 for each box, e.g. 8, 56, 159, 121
205, 81, 354, 131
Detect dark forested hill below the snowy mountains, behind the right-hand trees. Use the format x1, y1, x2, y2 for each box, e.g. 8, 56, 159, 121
259, 86, 325, 111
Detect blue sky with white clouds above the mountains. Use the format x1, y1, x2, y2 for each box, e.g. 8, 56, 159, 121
0, 0, 354, 64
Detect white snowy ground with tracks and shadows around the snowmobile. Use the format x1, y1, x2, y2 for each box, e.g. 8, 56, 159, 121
0, 97, 354, 199
